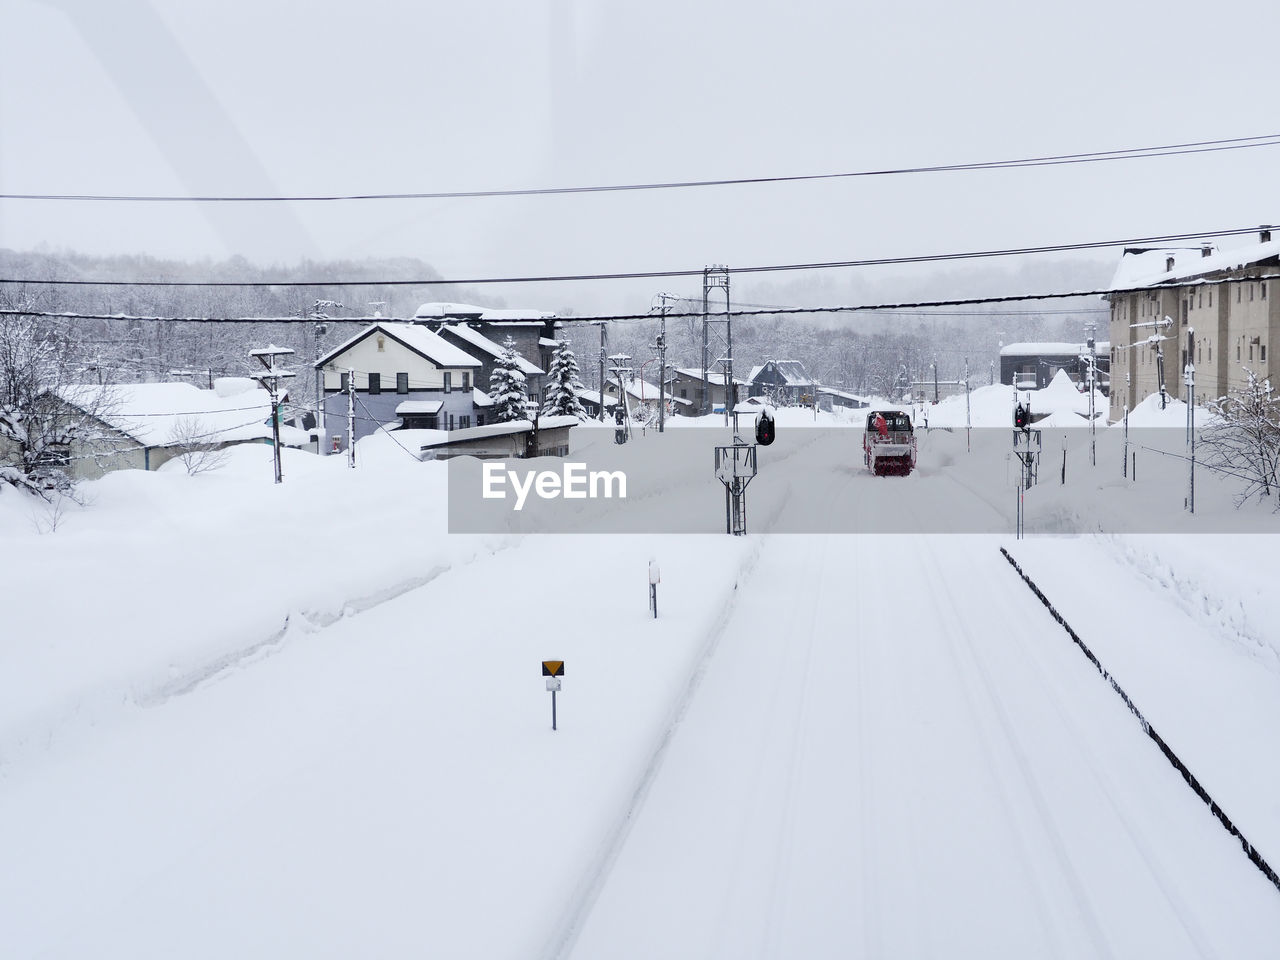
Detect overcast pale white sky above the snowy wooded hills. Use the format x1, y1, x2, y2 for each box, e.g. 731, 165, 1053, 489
0, 0, 1280, 308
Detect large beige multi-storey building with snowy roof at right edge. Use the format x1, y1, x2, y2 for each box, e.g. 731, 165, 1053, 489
1103, 227, 1280, 420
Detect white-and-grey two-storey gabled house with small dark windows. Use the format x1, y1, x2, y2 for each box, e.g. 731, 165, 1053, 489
316, 321, 488, 452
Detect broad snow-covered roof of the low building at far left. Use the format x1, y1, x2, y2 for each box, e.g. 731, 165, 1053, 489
58, 383, 271, 447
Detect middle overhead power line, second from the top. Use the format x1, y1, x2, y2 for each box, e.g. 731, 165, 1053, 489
0, 227, 1274, 288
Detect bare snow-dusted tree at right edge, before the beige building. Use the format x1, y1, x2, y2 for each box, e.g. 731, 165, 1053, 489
1201, 367, 1280, 508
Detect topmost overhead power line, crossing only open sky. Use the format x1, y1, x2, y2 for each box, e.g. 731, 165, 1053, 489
0, 133, 1280, 204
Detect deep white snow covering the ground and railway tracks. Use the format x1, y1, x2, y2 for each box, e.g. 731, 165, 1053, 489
0, 414, 1280, 957
